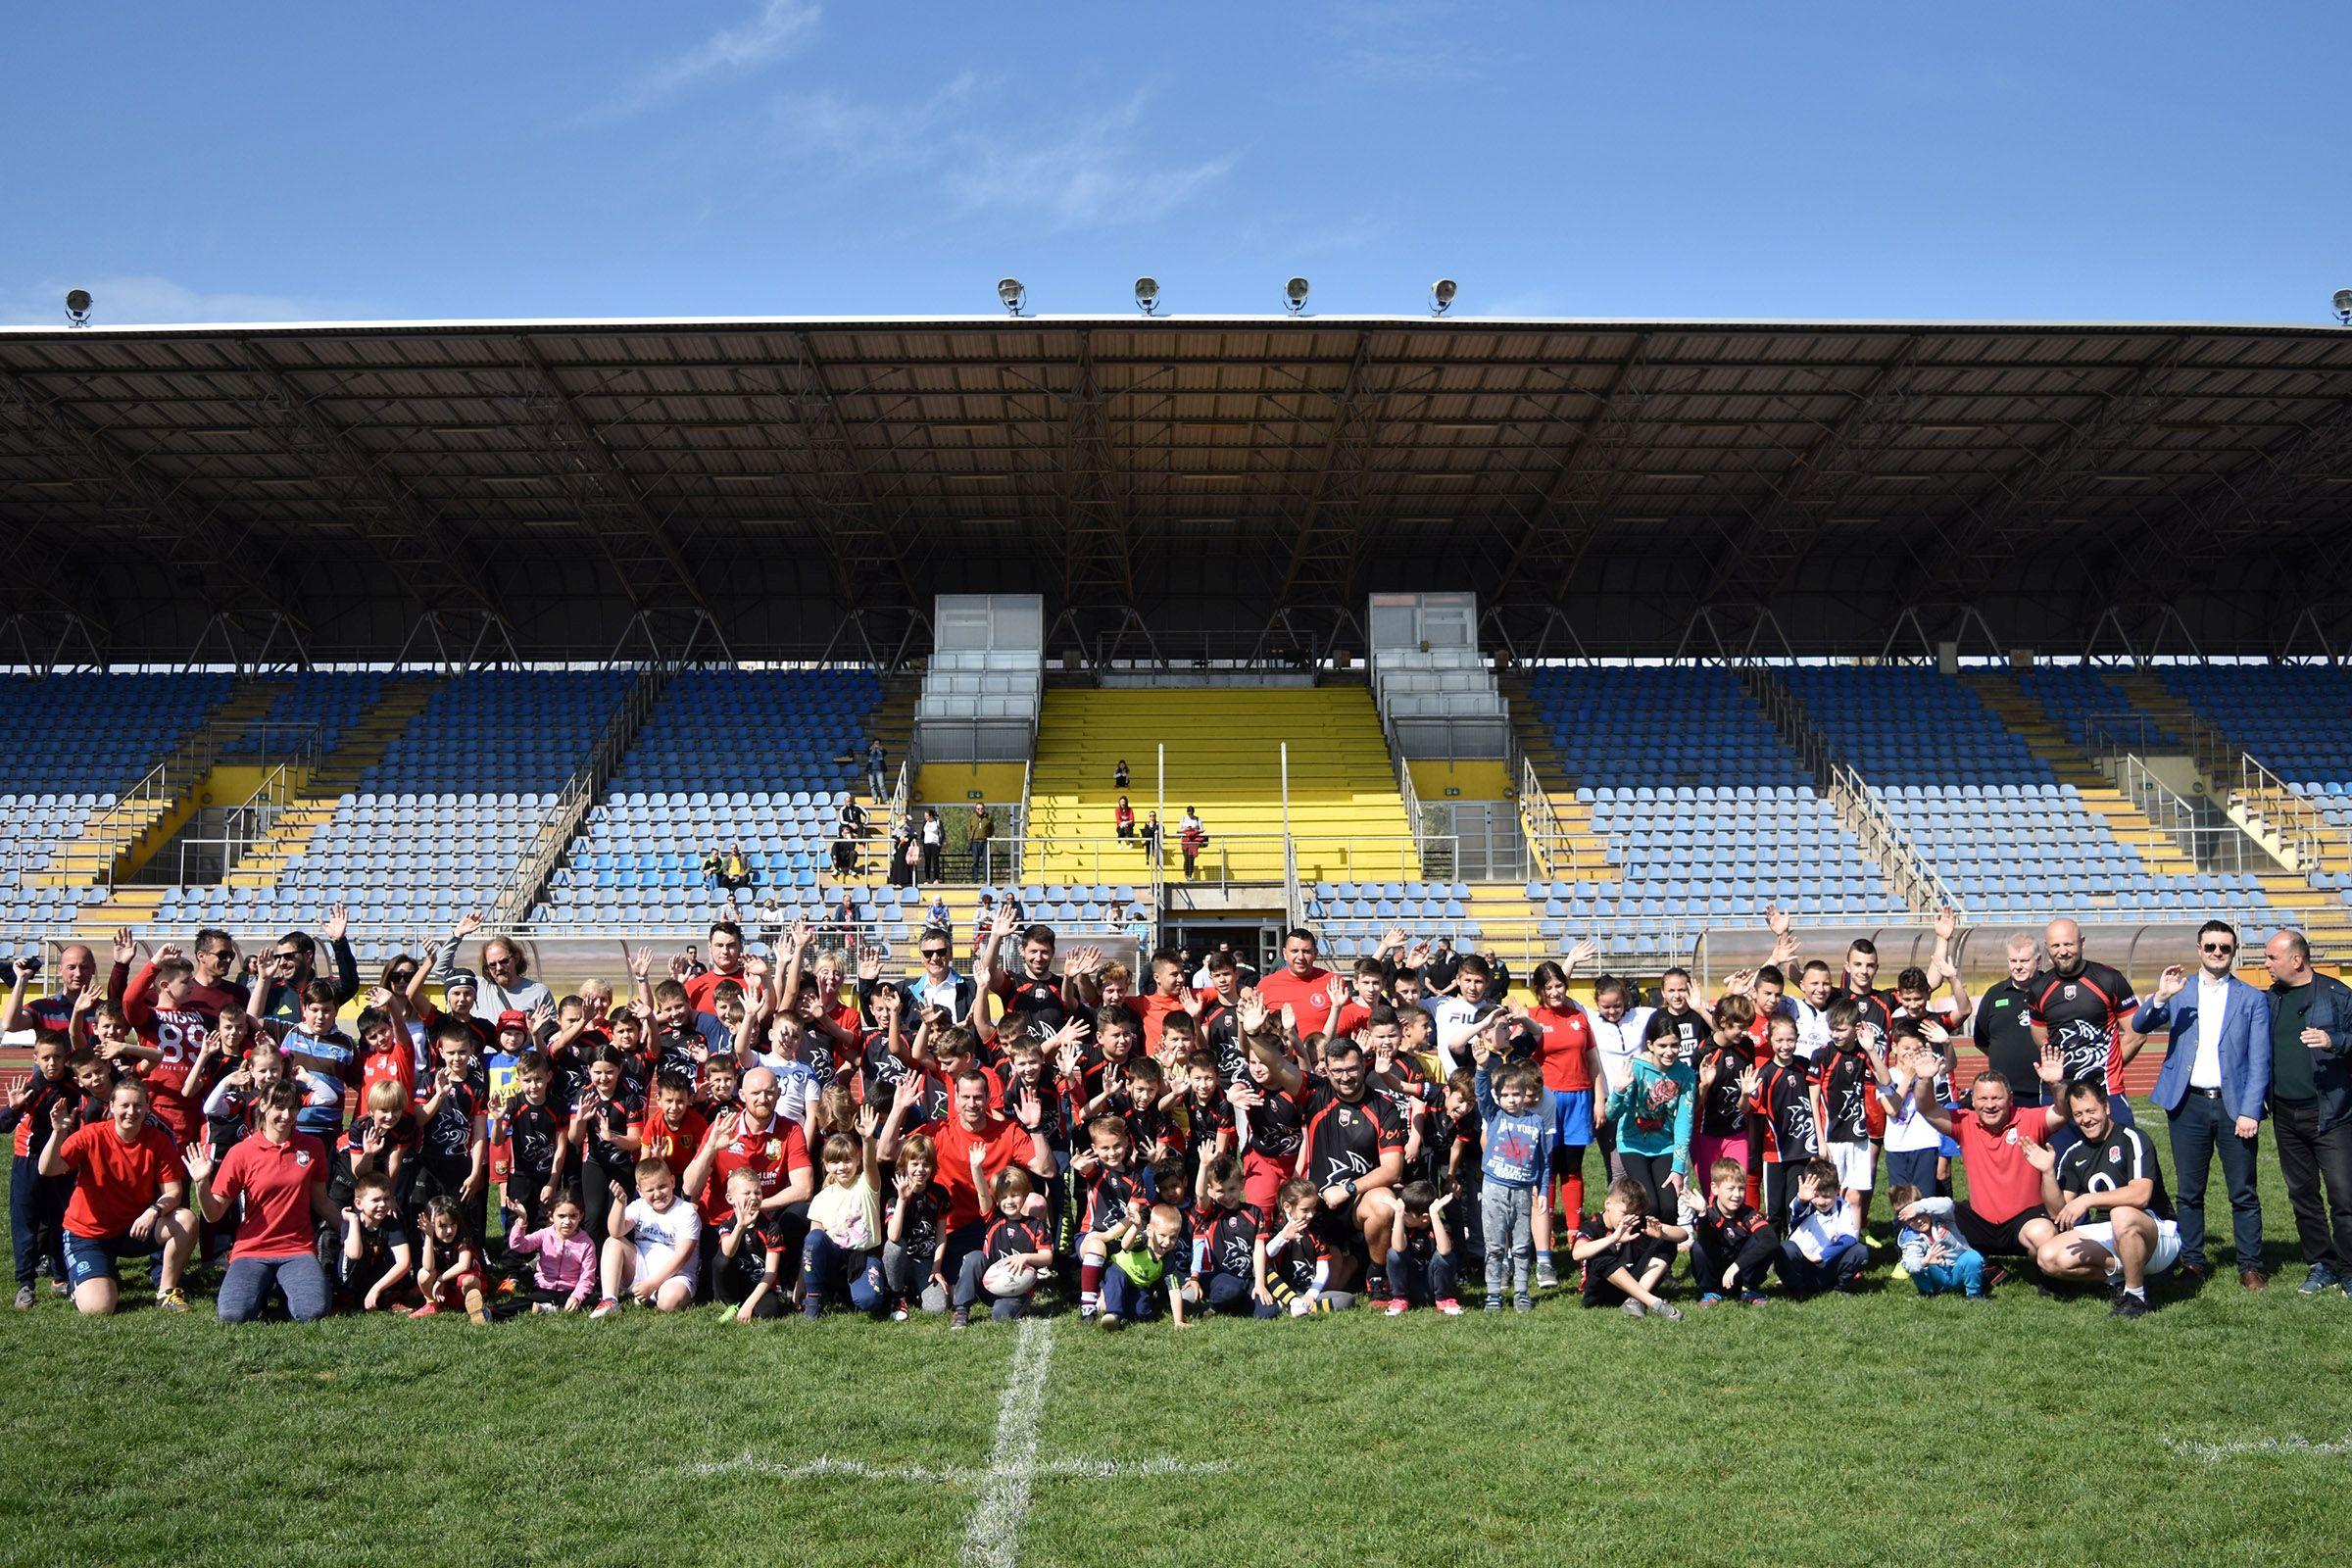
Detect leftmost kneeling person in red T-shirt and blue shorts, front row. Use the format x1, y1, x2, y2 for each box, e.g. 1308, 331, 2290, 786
40, 1079, 195, 1316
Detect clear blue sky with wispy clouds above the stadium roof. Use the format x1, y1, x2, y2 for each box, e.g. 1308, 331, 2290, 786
0, 0, 2352, 324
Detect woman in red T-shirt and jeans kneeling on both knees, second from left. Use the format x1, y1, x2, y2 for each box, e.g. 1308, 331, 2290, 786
188, 1084, 334, 1324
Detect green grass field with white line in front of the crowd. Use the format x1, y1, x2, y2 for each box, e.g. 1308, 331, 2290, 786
0, 1119, 2352, 1568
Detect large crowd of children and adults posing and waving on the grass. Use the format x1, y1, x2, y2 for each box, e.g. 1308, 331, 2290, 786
0, 907, 2352, 1328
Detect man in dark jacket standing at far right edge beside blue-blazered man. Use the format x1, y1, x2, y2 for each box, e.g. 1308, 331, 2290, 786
2263, 931, 2352, 1298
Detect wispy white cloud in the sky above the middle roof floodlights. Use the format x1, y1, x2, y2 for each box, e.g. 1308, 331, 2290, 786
776, 71, 1240, 230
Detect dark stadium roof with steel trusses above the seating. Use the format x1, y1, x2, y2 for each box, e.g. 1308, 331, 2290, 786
0, 315, 2352, 659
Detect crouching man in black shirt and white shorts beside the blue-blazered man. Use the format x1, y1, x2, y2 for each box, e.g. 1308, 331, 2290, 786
2023, 1079, 2180, 1316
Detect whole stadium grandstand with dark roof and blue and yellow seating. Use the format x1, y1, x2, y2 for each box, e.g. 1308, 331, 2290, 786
0, 315, 2352, 992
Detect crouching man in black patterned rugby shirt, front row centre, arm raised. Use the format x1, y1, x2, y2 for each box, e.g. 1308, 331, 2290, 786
1242, 1005, 1404, 1298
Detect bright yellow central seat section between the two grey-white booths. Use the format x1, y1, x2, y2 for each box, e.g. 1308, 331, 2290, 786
1021, 686, 1421, 882
